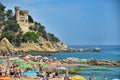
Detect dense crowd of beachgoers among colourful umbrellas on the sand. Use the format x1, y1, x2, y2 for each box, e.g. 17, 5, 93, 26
0, 52, 75, 80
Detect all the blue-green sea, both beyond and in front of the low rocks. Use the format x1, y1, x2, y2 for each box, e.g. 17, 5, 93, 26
53, 45, 120, 80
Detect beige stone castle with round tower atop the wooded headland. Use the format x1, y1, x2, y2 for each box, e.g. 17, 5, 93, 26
15, 6, 34, 33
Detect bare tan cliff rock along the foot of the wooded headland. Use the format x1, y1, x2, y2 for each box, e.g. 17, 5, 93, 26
0, 37, 67, 52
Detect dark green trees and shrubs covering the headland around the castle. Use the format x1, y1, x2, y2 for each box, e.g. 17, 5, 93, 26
0, 3, 60, 46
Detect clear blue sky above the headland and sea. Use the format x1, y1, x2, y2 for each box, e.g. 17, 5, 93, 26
0, 0, 120, 45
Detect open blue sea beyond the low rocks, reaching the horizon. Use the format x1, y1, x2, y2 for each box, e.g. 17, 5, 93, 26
54, 45, 120, 60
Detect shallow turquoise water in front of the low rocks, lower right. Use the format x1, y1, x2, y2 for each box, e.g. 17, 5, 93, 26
78, 66, 120, 80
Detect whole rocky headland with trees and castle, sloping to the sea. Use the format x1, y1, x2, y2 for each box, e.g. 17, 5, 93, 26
0, 3, 67, 52
